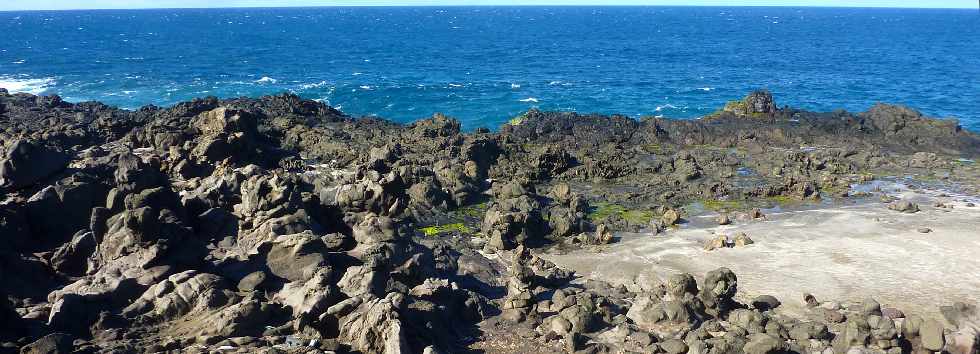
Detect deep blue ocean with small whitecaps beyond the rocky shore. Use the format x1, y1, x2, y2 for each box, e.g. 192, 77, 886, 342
0, 7, 980, 131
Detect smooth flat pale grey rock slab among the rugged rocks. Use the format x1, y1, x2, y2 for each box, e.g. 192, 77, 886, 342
542, 191, 980, 317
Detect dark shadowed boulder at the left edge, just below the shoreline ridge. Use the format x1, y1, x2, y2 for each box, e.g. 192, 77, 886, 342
0, 140, 71, 189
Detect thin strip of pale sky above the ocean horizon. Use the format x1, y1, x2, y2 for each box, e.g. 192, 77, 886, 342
0, 0, 977, 11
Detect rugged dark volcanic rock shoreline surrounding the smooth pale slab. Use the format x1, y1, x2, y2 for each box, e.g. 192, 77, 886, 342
0, 89, 980, 354
